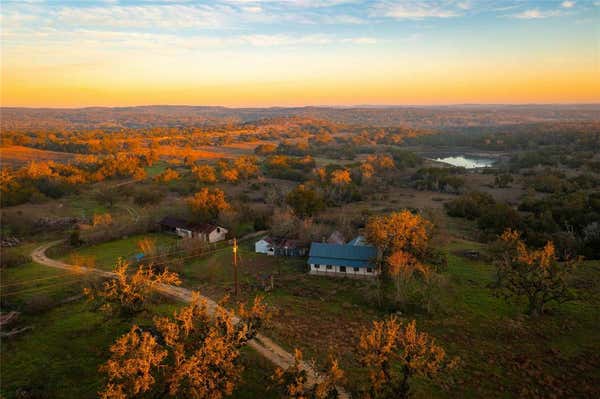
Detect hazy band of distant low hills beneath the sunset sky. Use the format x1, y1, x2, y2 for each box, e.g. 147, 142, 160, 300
1, 104, 600, 130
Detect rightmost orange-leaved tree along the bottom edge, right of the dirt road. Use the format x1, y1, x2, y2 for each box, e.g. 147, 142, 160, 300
358, 316, 457, 399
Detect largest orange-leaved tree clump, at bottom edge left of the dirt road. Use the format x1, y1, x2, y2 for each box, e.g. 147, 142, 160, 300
101, 293, 266, 399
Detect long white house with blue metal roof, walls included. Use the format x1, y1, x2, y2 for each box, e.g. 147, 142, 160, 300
308, 237, 377, 277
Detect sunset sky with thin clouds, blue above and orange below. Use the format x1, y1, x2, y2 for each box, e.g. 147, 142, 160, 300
0, 0, 600, 107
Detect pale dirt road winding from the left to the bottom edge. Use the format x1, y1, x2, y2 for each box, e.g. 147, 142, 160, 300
31, 240, 350, 399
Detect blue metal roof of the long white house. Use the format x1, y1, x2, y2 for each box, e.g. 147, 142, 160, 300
308, 242, 377, 267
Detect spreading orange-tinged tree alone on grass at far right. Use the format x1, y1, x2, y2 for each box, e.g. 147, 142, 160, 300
494, 229, 579, 316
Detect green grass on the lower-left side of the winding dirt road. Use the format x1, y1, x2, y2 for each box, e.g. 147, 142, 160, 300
0, 256, 275, 399
